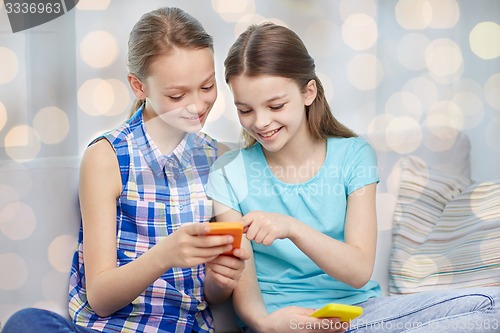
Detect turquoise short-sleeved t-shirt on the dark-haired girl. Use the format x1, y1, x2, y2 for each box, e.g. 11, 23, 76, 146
207, 138, 380, 312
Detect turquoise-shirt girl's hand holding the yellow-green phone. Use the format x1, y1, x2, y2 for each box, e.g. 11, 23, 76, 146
257, 306, 349, 333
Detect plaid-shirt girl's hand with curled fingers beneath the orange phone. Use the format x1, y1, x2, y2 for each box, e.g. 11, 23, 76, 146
206, 245, 250, 290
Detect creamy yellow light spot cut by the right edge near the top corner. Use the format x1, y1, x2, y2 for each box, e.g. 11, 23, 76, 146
469, 22, 500, 60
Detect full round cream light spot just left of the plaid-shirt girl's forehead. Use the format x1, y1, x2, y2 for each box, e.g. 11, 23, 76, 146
80, 31, 118, 68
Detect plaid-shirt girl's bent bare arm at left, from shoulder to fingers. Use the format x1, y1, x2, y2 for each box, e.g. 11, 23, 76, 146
79, 140, 230, 317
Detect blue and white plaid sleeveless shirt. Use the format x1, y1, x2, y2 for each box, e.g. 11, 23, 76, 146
69, 108, 217, 333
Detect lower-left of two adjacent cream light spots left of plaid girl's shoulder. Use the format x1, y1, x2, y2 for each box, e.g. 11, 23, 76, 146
4, 125, 41, 162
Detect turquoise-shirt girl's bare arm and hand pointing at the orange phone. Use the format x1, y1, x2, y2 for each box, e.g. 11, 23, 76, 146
243, 183, 377, 288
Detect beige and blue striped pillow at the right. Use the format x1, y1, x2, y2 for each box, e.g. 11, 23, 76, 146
389, 157, 500, 294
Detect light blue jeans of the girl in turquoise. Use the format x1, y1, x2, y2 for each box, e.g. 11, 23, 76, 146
348, 287, 500, 333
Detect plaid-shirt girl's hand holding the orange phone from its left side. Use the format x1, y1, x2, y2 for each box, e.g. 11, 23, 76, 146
161, 223, 233, 268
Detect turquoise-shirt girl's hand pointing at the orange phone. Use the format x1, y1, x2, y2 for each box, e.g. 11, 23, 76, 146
242, 210, 298, 245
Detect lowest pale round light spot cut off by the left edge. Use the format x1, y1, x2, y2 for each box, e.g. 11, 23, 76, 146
0, 253, 28, 290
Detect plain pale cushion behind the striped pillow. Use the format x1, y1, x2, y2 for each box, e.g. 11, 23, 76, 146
363, 127, 471, 295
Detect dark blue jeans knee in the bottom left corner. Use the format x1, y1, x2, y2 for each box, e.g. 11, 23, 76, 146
2, 308, 98, 333
